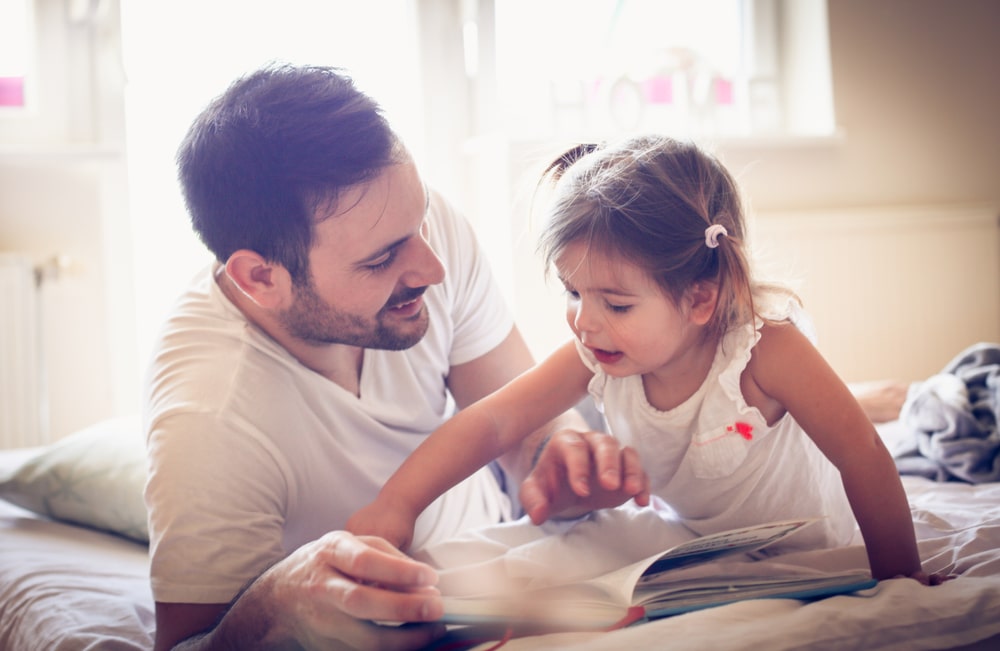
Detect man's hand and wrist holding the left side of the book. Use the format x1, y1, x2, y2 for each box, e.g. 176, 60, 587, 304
181, 531, 444, 651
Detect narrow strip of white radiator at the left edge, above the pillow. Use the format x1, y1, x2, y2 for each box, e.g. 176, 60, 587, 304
0, 253, 48, 448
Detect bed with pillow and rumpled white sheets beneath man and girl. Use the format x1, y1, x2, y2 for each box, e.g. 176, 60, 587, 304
0, 400, 1000, 651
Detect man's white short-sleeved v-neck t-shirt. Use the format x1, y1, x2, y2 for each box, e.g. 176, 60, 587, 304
145, 194, 513, 603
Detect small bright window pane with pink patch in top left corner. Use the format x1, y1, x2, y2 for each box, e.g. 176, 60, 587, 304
0, 0, 34, 111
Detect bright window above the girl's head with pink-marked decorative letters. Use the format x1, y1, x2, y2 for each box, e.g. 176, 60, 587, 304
477, 0, 833, 140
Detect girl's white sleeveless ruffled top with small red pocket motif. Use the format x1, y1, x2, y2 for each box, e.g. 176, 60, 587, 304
577, 296, 855, 551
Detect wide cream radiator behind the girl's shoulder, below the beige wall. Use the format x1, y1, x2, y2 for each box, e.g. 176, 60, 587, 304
751, 206, 1000, 381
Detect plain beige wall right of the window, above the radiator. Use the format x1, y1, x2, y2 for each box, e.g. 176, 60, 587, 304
722, 0, 1000, 211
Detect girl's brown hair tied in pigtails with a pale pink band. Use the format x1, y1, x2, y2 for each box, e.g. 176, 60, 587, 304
541, 135, 755, 344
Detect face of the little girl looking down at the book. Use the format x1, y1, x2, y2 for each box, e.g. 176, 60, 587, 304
555, 242, 703, 377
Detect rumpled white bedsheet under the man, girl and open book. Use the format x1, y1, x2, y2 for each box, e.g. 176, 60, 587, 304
0, 450, 1000, 651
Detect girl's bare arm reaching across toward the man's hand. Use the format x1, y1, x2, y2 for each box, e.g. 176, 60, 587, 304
347, 341, 592, 549
